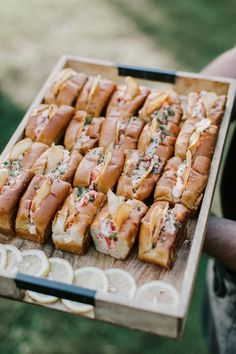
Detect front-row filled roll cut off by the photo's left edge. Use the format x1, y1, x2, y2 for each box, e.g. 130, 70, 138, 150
0, 168, 34, 235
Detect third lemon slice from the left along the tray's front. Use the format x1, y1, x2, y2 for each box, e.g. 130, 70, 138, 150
19, 250, 50, 277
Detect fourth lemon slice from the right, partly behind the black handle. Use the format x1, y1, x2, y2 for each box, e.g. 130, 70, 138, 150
27, 258, 74, 304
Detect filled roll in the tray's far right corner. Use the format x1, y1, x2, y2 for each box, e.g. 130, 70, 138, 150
187, 91, 227, 124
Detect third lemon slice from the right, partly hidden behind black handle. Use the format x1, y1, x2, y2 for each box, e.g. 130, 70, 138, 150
62, 267, 109, 314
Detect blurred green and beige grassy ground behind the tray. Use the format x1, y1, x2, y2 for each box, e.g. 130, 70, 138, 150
0, 0, 236, 354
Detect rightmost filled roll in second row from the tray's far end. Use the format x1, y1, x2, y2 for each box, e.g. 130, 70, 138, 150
175, 118, 219, 160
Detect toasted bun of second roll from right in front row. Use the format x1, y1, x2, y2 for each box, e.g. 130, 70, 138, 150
90, 199, 147, 259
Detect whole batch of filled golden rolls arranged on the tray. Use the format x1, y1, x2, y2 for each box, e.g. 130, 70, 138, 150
0, 68, 226, 268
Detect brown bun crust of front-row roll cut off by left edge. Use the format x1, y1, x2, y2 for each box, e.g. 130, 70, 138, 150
0, 170, 34, 235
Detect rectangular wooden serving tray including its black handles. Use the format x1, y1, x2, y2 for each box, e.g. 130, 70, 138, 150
0, 56, 236, 338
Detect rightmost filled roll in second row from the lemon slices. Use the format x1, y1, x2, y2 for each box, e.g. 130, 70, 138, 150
154, 150, 211, 211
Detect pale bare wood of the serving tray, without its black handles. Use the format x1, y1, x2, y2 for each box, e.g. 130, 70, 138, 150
0, 57, 236, 337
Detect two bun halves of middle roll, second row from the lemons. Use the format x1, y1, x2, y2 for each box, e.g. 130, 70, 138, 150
73, 148, 124, 193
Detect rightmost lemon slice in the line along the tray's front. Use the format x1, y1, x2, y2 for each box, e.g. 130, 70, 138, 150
135, 280, 179, 307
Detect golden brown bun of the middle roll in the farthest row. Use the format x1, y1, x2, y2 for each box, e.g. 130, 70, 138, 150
106, 85, 150, 119
